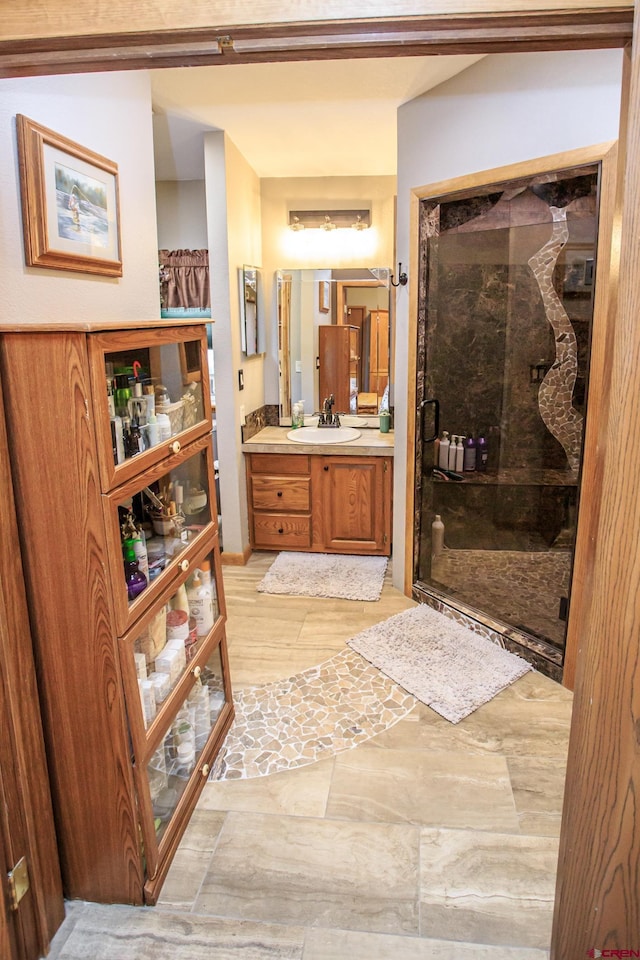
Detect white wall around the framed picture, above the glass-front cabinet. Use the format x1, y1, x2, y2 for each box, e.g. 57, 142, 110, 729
0, 71, 160, 322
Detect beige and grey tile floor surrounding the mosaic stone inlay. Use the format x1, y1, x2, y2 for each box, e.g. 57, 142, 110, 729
50, 554, 571, 960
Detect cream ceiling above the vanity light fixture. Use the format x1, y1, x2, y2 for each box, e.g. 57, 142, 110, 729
151, 56, 482, 180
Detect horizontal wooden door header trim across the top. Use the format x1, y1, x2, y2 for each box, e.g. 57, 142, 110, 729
0, 7, 633, 77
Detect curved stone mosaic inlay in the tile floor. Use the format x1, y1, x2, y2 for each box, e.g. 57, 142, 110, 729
210, 648, 417, 780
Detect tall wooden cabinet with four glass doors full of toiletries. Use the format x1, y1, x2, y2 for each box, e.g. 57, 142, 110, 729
0, 321, 233, 904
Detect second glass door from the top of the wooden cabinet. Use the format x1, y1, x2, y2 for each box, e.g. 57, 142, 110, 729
105, 436, 218, 633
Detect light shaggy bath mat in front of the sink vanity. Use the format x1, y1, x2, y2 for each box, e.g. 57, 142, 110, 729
257, 552, 387, 600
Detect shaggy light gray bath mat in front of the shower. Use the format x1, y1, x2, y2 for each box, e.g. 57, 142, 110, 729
347, 604, 533, 723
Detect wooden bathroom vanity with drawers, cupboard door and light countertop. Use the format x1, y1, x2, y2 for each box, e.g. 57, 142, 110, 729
242, 427, 393, 556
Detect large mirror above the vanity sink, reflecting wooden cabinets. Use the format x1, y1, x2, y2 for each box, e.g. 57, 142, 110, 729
276, 268, 393, 423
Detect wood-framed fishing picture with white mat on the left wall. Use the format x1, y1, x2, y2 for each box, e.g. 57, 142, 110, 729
16, 114, 122, 277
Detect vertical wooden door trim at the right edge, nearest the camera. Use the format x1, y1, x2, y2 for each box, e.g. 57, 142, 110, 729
551, 28, 640, 948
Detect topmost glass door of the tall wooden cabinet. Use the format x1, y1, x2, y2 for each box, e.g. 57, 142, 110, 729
89, 327, 211, 489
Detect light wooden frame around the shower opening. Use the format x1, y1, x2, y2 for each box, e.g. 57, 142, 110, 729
404, 141, 619, 689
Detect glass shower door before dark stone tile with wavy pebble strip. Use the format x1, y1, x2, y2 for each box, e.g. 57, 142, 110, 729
414, 165, 599, 662
